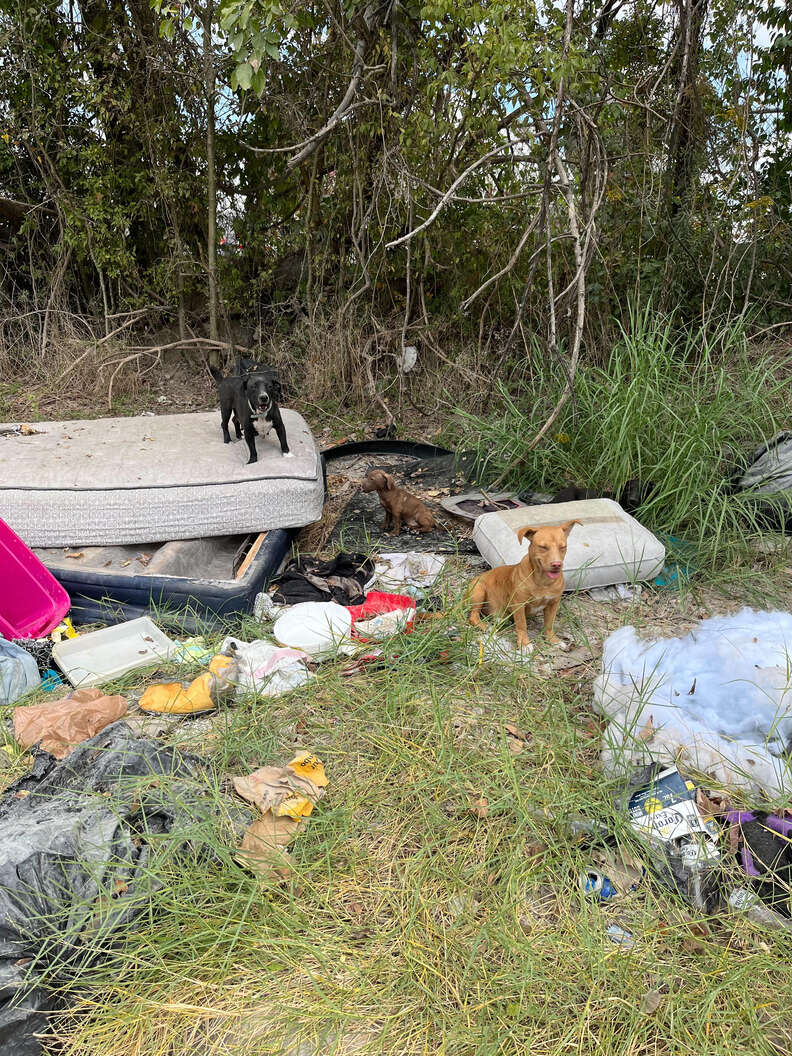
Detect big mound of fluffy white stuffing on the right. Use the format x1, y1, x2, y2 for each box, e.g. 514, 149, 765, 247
593, 608, 792, 796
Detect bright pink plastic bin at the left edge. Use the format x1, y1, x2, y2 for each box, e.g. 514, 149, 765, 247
0, 520, 72, 638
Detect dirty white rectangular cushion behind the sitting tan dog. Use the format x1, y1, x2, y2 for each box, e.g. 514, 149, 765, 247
473, 498, 665, 590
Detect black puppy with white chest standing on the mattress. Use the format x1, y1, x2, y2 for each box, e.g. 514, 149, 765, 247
209, 359, 290, 465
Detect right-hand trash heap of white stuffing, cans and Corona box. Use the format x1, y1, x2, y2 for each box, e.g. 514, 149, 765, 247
571, 608, 792, 931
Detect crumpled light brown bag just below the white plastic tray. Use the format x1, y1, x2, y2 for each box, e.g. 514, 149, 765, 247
14, 690, 127, 759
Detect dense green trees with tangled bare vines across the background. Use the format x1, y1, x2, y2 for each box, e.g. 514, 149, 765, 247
0, 0, 792, 371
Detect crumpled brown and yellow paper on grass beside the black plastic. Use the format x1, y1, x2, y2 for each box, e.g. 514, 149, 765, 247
233, 751, 329, 880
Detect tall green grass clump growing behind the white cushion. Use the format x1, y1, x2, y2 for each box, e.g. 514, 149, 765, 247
458, 307, 790, 568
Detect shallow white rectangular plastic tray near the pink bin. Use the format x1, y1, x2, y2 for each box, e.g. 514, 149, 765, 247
52, 616, 174, 686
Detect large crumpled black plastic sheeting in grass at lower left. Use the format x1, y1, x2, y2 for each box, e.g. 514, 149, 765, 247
0, 720, 241, 1056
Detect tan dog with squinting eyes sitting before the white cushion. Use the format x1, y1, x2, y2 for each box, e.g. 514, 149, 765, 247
468, 521, 580, 648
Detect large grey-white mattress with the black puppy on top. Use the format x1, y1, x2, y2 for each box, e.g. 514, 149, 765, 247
0, 410, 324, 546
